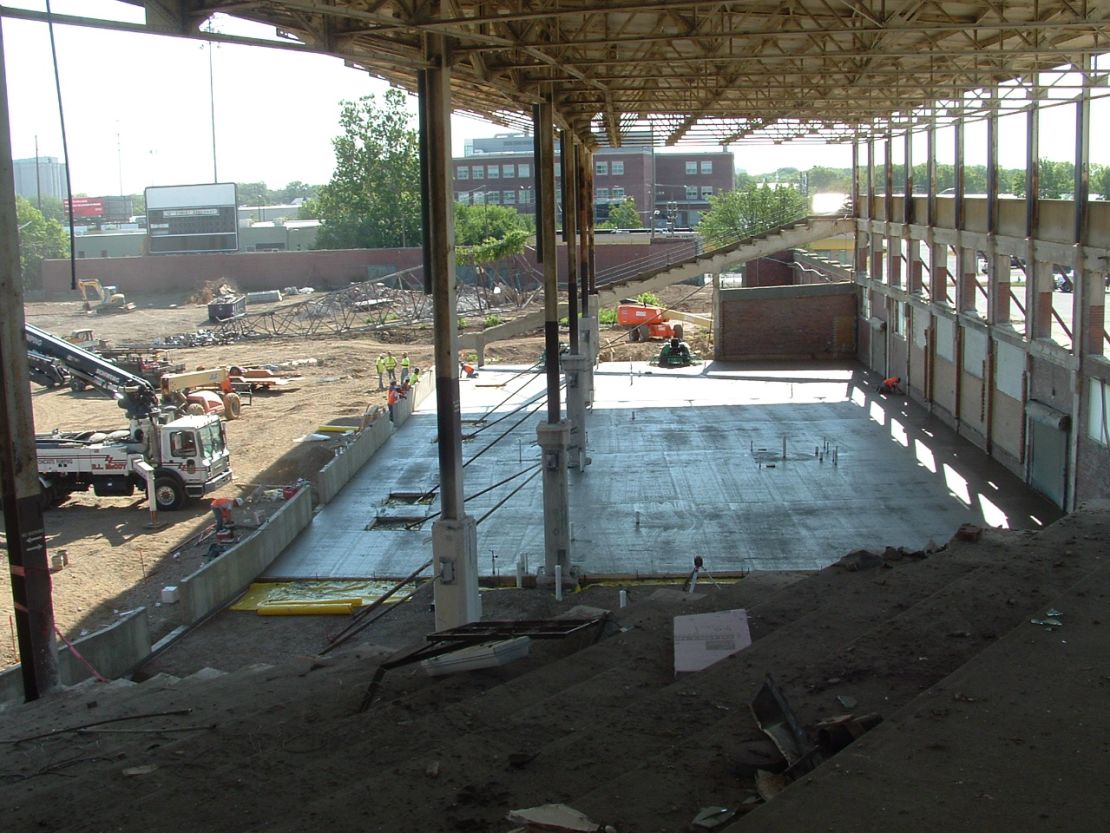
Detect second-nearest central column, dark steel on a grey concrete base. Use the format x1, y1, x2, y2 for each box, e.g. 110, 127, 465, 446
534, 96, 571, 580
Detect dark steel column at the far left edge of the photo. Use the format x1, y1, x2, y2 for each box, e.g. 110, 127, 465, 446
0, 23, 58, 700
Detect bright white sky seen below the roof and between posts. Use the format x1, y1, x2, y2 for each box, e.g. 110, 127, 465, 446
0, 0, 1110, 197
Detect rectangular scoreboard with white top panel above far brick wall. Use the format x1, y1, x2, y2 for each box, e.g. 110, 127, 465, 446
145, 182, 239, 254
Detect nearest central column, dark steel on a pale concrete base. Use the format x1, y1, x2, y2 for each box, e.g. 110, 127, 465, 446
418, 34, 482, 630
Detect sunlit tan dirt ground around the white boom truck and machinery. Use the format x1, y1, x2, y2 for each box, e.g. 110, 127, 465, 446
0, 285, 710, 668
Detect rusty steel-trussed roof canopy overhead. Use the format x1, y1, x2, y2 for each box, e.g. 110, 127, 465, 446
99, 0, 1110, 145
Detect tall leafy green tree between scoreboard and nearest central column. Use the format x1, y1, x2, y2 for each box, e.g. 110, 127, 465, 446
316, 89, 421, 249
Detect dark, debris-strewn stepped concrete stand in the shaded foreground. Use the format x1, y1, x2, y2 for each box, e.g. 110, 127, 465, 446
0, 510, 1110, 833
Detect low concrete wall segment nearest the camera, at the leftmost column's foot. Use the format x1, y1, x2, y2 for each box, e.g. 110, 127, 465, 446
0, 608, 151, 702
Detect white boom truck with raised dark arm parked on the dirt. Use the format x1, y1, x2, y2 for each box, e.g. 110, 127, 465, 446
26, 324, 232, 511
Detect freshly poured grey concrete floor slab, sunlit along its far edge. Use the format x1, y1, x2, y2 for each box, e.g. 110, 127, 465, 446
268, 362, 1060, 579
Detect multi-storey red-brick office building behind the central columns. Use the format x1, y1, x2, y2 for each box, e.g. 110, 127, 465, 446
453, 136, 735, 228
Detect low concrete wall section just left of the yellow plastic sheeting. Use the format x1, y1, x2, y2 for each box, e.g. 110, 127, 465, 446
178, 489, 312, 624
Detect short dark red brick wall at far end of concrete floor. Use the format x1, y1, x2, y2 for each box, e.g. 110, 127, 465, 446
715, 283, 858, 361
